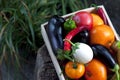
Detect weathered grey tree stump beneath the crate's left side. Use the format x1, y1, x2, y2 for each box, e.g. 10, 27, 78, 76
34, 45, 59, 80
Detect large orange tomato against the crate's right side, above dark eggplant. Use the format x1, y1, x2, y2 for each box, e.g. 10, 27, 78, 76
90, 25, 115, 48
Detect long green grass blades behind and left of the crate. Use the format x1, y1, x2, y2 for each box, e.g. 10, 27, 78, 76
0, 0, 88, 79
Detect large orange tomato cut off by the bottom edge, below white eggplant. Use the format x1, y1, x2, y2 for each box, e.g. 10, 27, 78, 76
85, 59, 107, 80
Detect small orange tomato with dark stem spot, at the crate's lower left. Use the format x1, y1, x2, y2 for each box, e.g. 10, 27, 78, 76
65, 61, 85, 79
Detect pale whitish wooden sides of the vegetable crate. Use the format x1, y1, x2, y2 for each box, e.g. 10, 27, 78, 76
41, 5, 119, 80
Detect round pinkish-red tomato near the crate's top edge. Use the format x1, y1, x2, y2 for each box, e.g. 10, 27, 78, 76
73, 11, 93, 30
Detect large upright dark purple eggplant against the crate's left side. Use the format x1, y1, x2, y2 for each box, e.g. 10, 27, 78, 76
46, 15, 65, 54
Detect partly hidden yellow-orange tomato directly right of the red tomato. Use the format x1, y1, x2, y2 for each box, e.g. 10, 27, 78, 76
91, 13, 104, 27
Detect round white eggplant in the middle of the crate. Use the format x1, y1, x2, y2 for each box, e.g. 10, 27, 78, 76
73, 43, 93, 64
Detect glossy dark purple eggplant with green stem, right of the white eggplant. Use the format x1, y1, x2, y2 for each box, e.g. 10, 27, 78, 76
91, 44, 116, 68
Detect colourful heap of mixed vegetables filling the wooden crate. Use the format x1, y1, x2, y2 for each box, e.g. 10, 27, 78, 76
45, 7, 120, 80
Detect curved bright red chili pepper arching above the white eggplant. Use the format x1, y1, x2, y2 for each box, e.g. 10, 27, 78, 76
64, 26, 85, 51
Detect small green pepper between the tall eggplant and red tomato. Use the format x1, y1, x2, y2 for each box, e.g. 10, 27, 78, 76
64, 16, 76, 32
